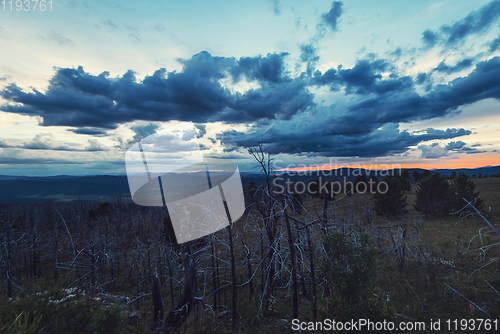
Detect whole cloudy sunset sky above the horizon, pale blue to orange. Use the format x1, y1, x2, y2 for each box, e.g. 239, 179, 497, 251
0, 0, 500, 176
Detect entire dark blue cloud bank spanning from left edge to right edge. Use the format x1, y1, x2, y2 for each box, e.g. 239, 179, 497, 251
0, 49, 500, 156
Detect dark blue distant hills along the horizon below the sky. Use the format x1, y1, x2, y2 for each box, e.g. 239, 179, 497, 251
0, 166, 500, 203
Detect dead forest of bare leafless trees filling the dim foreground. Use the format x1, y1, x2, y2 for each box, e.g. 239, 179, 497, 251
0, 147, 500, 333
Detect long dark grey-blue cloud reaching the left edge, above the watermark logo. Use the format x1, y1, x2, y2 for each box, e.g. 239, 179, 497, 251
0, 52, 313, 132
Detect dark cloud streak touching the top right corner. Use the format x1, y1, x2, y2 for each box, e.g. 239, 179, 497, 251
422, 0, 500, 47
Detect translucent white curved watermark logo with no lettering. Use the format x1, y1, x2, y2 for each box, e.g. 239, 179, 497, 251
125, 123, 245, 244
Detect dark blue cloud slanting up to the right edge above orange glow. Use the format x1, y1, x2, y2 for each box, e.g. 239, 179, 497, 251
219, 57, 500, 157
